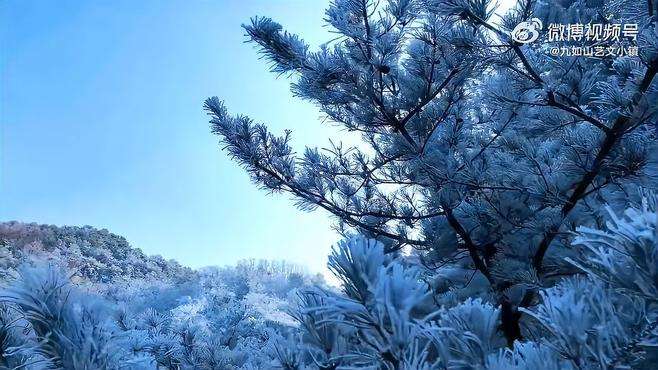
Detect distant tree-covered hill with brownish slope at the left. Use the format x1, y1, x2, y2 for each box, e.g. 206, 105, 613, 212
0, 221, 197, 283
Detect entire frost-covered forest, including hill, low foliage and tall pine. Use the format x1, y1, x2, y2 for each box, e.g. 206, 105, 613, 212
0, 0, 658, 370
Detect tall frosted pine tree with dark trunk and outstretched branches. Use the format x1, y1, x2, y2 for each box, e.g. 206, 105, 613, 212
205, 0, 658, 368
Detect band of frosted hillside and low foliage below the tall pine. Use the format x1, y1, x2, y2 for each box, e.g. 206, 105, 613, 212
0, 201, 658, 370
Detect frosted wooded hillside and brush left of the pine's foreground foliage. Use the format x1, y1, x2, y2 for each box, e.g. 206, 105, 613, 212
0, 222, 323, 369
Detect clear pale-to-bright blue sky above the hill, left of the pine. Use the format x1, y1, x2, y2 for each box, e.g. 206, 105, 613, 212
0, 0, 337, 271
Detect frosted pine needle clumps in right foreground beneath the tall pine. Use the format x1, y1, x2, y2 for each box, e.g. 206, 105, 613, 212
288, 210, 658, 370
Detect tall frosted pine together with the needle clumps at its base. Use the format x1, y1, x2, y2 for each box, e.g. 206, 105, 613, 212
205, 0, 658, 369
